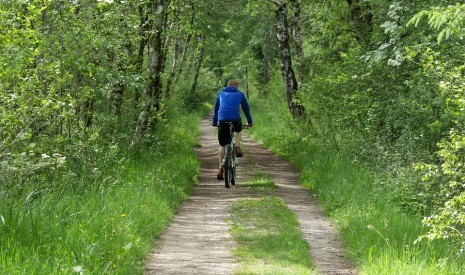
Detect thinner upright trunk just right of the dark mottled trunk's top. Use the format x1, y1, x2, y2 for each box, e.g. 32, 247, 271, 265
289, 0, 304, 85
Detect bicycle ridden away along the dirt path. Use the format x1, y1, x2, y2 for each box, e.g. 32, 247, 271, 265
222, 122, 248, 188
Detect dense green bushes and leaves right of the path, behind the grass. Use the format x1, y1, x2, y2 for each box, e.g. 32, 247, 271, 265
236, 0, 465, 264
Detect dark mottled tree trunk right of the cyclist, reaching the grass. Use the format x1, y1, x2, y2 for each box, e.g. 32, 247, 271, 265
275, 0, 304, 119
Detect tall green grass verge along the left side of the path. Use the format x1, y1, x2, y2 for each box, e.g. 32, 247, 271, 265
0, 107, 207, 274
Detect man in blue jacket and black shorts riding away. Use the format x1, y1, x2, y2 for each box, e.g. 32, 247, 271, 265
213, 79, 252, 180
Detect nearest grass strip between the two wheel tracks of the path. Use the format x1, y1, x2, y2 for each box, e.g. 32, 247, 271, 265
230, 196, 316, 274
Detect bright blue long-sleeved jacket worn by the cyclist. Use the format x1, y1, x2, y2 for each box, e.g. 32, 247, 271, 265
213, 87, 252, 126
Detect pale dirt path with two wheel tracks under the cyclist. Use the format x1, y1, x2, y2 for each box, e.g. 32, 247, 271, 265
146, 114, 356, 274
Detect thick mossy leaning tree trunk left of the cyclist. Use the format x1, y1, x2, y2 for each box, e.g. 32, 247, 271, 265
131, 0, 169, 147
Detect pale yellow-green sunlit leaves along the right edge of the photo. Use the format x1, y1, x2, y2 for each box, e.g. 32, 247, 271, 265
409, 4, 465, 254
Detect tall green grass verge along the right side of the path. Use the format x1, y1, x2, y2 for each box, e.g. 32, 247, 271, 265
246, 91, 465, 274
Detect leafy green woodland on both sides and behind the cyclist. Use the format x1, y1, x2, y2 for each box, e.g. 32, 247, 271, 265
0, 0, 465, 271
